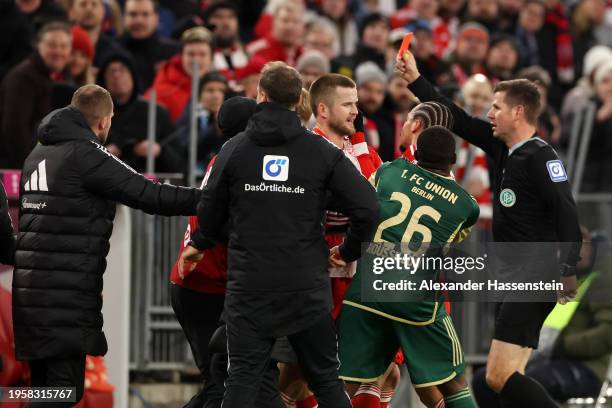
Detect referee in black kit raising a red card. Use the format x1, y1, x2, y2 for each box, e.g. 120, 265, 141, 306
396, 52, 581, 407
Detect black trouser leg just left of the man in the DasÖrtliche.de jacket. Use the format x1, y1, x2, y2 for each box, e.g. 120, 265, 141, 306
170, 284, 225, 408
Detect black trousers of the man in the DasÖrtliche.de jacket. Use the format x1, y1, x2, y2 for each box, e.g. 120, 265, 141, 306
223, 314, 351, 408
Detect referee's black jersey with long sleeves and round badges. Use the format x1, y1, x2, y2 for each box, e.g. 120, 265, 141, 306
408, 76, 582, 266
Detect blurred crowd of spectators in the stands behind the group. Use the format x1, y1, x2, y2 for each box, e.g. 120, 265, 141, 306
0, 0, 612, 198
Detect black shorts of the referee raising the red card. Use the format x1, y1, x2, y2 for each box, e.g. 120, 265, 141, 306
493, 302, 556, 349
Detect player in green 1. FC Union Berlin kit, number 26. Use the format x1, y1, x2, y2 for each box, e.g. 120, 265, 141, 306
330, 126, 479, 408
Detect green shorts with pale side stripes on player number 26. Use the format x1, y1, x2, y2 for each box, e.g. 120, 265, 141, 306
339, 304, 465, 388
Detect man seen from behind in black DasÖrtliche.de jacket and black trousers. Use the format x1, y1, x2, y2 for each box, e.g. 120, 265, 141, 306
182, 62, 378, 408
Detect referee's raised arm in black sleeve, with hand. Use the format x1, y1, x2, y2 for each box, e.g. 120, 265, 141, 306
395, 52, 505, 160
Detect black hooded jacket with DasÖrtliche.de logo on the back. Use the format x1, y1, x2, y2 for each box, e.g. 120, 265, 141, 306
192, 102, 378, 337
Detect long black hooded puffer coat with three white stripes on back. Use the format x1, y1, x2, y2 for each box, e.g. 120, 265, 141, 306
13, 106, 200, 360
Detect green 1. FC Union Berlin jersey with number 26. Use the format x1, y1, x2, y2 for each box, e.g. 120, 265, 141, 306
344, 158, 480, 325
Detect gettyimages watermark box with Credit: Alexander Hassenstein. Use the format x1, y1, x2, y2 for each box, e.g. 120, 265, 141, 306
358, 242, 611, 302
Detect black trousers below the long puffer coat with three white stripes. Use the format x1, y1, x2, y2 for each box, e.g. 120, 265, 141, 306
26, 355, 85, 408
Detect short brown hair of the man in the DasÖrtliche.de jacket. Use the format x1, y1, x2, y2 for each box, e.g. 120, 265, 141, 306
259, 61, 302, 109
